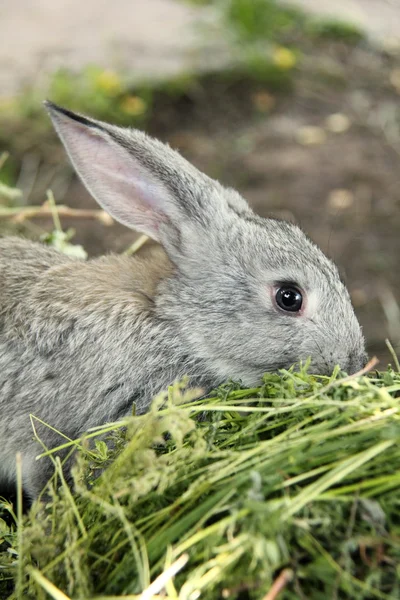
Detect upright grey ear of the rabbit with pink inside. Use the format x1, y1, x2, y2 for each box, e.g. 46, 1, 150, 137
45, 102, 217, 243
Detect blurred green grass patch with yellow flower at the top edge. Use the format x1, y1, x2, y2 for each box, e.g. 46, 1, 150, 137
184, 0, 364, 90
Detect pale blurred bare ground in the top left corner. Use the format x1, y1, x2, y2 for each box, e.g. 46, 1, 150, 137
0, 0, 217, 99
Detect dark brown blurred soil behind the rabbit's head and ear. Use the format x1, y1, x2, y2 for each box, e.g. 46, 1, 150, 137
0, 42, 400, 368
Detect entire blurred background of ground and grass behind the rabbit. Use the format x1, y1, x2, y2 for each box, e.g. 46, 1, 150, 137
0, 0, 400, 368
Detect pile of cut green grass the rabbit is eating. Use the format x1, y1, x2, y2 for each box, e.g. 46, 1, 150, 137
0, 368, 400, 600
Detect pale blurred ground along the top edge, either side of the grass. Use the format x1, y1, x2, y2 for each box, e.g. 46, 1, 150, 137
0, 0, 400, 99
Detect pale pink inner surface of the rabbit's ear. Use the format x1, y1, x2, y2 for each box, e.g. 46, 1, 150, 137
50, 117, 172, 241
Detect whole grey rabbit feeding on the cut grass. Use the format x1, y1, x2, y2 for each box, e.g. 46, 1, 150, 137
0, 101, 366, 499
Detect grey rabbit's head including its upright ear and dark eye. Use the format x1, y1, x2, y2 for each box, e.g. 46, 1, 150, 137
47, 103, 366, 385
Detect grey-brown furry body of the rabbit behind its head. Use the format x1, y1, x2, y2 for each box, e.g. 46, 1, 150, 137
0, 238, 178, 493
